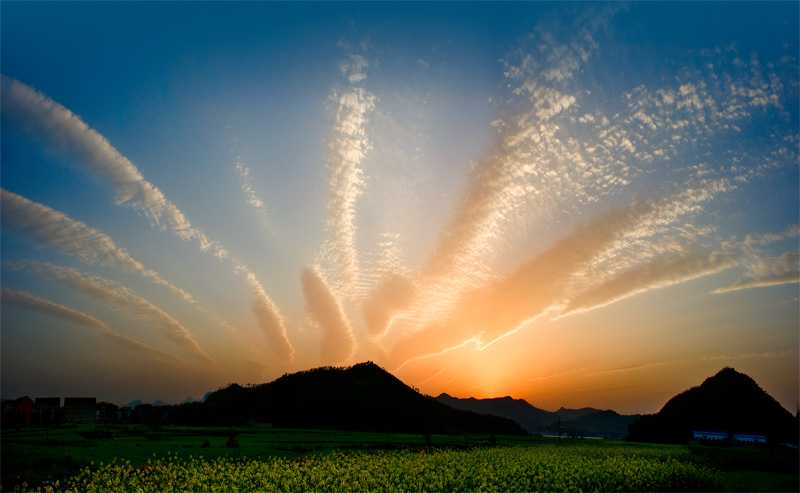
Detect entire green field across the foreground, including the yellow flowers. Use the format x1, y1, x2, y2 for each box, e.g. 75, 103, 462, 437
0, 425, 798, 491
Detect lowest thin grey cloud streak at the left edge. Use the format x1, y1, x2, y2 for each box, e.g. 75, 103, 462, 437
0, 288, 183, 367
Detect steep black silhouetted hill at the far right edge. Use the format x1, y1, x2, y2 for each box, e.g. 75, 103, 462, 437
629, 368, 798, 444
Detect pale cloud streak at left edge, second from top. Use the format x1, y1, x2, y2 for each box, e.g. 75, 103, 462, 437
0, 189, 194, 302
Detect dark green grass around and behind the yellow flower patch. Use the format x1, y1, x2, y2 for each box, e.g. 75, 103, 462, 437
0, 425, 800, 491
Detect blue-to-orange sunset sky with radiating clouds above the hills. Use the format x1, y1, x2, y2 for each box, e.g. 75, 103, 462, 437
0, 2, 800, 414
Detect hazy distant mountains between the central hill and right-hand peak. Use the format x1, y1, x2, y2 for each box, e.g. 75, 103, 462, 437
436, 394, 639, 438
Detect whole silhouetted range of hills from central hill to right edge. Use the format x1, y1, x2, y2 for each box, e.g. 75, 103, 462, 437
12, 362, 800, 444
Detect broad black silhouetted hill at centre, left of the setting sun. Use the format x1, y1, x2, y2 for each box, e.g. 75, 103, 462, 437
203, 362, 525, 434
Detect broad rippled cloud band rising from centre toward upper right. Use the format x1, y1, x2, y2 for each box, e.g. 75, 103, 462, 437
362, 8, 625, 336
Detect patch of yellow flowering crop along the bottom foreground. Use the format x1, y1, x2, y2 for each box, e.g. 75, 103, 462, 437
14, 444, 721, 492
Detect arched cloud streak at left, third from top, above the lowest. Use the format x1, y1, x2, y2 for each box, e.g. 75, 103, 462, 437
5, 261, 216, 365
